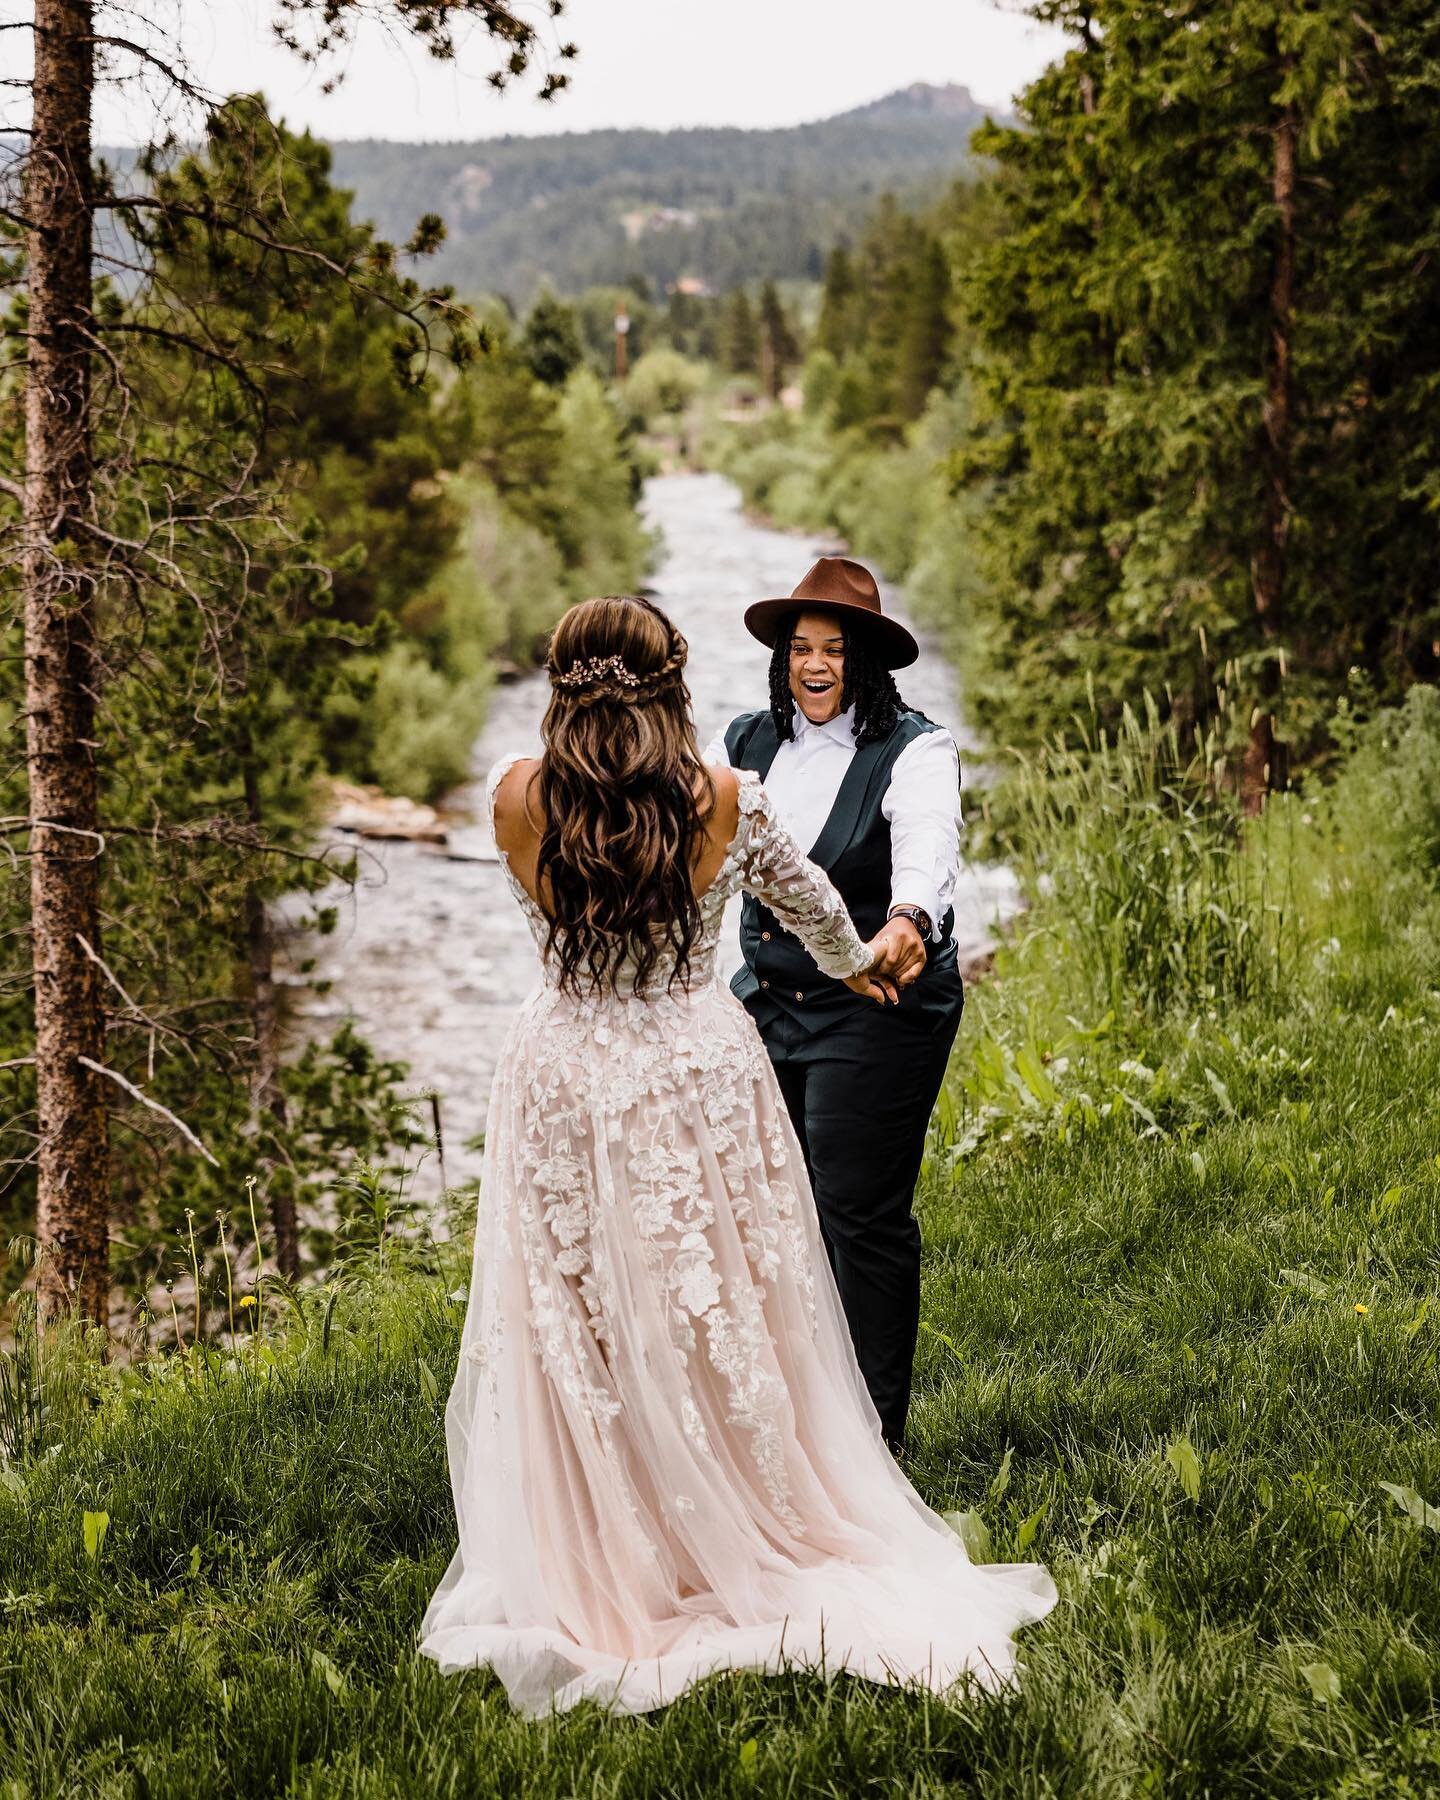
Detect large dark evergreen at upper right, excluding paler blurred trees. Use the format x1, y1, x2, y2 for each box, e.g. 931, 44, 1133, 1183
958, 0, 1440, 766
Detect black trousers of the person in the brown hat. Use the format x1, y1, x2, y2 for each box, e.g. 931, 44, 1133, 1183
751, 976, 963, 1449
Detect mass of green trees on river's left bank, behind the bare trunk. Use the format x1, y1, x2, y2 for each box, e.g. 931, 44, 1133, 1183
0, 97, 652, 1323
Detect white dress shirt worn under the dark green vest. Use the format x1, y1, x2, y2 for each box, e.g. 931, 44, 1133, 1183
706, 706, 963, 938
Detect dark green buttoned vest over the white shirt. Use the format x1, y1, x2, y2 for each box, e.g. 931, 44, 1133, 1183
725, 707, 959, 1030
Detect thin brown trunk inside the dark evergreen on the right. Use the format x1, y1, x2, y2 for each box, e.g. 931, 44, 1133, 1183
1240, 73, 1300, 812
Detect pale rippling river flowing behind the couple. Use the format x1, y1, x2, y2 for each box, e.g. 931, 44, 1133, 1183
281, 473, 1017, 1195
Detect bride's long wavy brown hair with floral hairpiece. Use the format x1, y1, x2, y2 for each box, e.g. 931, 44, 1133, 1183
536, 596, 715, 994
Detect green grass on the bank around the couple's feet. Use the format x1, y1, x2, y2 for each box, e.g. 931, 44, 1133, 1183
0, 695, 1440, 1800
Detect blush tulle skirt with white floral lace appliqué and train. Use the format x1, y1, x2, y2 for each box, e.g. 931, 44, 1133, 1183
421, 985, 1055, 1714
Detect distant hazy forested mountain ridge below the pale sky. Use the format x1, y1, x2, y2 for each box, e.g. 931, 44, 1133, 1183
333, 85, 985, 304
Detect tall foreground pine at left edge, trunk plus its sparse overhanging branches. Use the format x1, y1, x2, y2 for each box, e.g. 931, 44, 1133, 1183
4, 0, 572, 1319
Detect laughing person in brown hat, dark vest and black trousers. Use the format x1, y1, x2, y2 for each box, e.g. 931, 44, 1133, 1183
706, 556, 965, 1453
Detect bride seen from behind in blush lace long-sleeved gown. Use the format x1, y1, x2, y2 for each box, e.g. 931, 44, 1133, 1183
421, 599, 1055, 1714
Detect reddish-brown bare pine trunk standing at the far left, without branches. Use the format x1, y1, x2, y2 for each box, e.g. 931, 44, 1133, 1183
23, 0, 110, 1321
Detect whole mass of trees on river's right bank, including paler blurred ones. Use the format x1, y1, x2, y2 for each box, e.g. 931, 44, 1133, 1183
727, 0, 1440, 770
